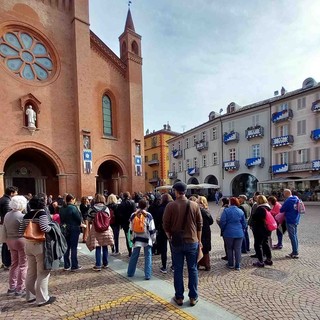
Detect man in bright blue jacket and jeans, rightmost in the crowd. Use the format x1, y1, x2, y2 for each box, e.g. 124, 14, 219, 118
280, 189, 300, 259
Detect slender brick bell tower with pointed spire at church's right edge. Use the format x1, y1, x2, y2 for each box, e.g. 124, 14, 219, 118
119, 6, 145, 191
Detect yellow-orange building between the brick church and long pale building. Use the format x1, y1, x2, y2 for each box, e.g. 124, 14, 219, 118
145, 124, 179, 191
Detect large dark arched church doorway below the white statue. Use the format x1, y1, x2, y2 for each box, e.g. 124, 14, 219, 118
4, 148, 59, 196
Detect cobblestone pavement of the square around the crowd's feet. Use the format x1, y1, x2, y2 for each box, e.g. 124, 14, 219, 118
0, 205, 320, 320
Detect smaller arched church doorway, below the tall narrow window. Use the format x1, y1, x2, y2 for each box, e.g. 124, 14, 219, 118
96, 160, 127, 195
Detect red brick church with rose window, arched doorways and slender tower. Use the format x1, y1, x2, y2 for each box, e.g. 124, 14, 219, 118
0, 0, 144, 197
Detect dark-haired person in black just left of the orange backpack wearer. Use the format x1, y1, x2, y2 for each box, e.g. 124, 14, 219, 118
118, 192, 136, 257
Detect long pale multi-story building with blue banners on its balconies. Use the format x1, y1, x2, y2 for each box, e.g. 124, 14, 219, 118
169, 78, 320, 200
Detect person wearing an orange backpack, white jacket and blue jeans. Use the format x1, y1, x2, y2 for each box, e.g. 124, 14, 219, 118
127, 199, 156, 280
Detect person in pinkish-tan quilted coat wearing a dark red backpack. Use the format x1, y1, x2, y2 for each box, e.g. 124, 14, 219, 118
87, 193, 114, 271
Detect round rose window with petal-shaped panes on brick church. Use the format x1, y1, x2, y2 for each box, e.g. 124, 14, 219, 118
0, 31, 54, 81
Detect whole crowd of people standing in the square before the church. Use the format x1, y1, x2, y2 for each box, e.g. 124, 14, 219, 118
0, 182, 300, 307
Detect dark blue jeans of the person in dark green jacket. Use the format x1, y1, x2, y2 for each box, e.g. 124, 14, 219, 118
63, 225, 80, 269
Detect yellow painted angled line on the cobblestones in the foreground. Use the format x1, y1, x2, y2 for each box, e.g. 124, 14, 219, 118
64, 292, 196, 320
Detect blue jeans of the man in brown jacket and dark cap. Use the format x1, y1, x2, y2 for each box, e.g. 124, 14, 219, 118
171, 242, 199, 299
